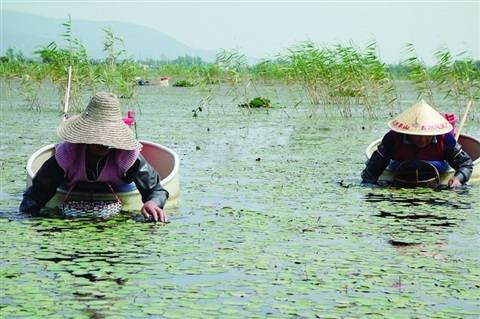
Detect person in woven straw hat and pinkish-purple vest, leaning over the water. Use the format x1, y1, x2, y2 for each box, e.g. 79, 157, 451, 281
19, 92, 169, 222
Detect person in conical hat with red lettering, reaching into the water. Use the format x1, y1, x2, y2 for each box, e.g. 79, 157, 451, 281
361, 100, 473, 188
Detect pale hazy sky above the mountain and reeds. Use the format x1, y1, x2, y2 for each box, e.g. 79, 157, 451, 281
0, 0, 480, 63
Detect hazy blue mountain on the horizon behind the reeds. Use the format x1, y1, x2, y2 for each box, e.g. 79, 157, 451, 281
0, 11, 218, 62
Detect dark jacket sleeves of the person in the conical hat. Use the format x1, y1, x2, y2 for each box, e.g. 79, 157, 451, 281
361, 132, 473, 184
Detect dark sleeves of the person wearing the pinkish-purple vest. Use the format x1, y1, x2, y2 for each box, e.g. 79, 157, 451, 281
19, 154, 169, 215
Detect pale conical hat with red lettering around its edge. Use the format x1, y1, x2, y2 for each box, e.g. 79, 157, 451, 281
388, 100, 453, 135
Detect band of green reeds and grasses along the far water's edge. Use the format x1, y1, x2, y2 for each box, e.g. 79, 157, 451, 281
0, 17, 480, 120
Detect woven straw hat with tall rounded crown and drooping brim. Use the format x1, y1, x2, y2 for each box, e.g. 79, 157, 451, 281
57, 92, 142, 150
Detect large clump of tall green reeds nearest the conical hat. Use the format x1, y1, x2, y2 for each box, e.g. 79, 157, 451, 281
264, 41, 396, 117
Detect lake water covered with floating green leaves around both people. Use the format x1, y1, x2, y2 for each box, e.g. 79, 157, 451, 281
0, 81, 480, 318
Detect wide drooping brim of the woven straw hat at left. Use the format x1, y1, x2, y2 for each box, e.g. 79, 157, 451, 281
57, 113, 142, 150
